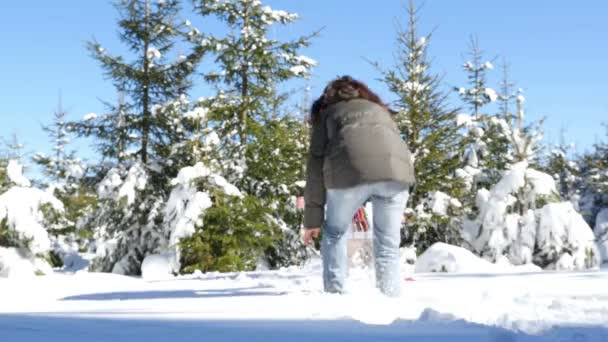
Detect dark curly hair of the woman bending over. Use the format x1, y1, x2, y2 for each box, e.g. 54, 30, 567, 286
310, 76, 395, 123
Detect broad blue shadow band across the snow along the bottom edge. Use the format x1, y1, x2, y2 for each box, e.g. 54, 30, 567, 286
0, 313, 608, 342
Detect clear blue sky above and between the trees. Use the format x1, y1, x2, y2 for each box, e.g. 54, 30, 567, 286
0, 0, 608, 167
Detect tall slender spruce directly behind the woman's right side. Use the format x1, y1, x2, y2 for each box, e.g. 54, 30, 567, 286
376, 1, 464, 251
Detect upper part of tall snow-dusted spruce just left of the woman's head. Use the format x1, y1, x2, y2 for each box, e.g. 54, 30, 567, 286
195, 0, 316, 145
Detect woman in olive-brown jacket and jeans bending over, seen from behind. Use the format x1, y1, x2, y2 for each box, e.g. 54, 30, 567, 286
304, 76, 414, 296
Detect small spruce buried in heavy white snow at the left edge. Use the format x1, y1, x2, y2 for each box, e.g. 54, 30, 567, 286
0, 160, 63, 277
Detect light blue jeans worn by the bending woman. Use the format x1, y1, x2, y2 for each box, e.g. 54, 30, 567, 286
321, 182, 409, 297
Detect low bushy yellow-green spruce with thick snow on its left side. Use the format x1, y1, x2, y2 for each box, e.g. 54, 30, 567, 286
172, 162, 280, 273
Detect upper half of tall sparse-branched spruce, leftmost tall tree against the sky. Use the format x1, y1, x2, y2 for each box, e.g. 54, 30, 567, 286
81, 0, 207, 170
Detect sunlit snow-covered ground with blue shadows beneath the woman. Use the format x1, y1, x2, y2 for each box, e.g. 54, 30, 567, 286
0, 260, 608, 342
